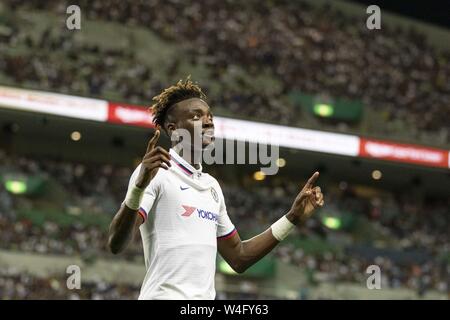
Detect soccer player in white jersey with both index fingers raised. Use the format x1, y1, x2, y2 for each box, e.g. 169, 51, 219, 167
108, 78, 324, 299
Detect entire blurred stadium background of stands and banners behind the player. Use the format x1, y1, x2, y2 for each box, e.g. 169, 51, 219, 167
0, 0, 450, 299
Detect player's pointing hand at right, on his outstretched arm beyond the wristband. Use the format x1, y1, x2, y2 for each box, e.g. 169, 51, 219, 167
286, 172, 324, 224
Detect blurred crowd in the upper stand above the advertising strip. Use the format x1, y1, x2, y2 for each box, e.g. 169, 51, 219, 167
0, 0, 450, 143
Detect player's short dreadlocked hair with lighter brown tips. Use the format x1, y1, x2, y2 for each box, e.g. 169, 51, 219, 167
150, 76, 206, 127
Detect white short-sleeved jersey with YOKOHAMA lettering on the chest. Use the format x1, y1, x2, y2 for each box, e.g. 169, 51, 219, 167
124, 149, 236, 300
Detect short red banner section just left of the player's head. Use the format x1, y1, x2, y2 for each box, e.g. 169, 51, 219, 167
108, 102, 155, 128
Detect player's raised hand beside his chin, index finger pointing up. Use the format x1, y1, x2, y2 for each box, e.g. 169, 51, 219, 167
136, 130, 171, 189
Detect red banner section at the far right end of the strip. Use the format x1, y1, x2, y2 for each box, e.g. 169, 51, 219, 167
359, 138, 449, 168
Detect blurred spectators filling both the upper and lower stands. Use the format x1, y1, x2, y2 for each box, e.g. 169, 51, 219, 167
0, 0, 450, 299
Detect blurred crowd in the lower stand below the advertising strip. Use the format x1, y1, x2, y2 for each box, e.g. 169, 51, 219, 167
0, 152, 450, 298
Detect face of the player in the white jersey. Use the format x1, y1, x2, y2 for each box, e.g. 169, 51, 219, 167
174, 98, 215, 149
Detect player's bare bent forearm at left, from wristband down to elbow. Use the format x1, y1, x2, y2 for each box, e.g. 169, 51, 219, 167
108, 205, 139, 254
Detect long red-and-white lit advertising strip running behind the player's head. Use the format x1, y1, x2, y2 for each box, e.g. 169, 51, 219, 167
0, 86, 450, 168
